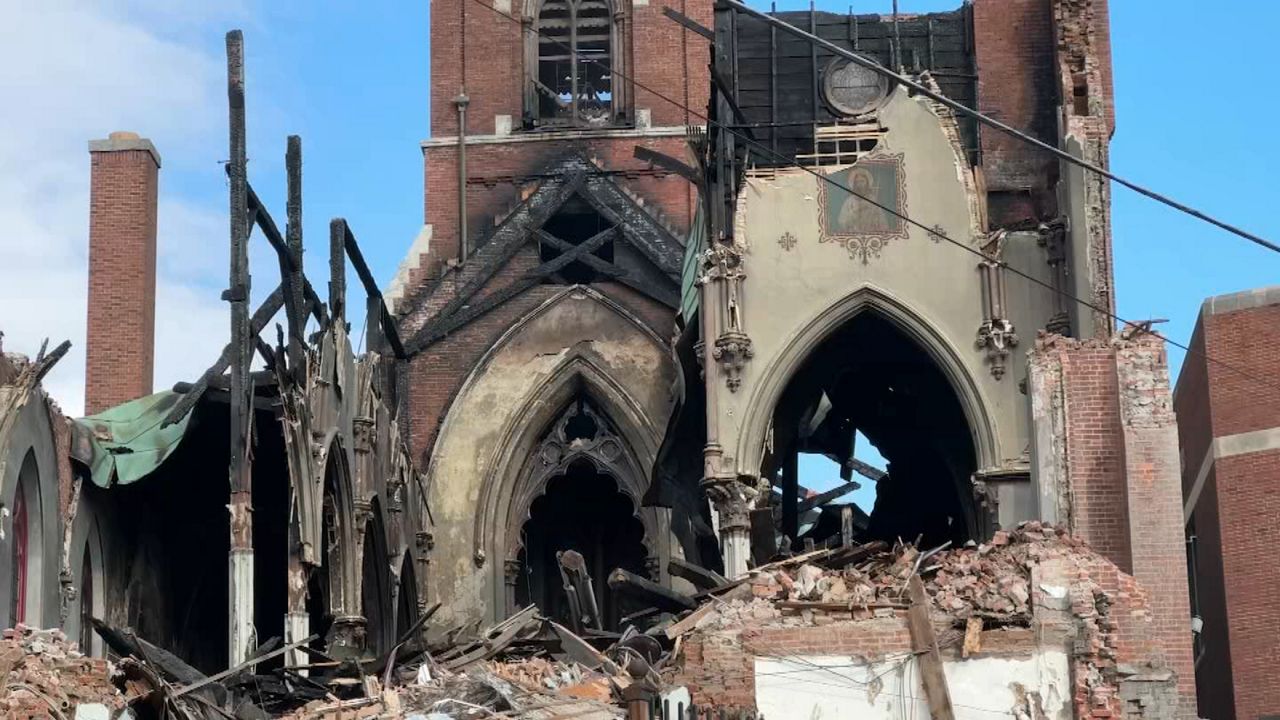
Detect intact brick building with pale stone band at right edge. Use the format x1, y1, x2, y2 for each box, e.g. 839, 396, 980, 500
1174, 287, 1280, 720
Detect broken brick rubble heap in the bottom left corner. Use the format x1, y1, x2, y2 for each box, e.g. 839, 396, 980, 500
0, 625, 124, 717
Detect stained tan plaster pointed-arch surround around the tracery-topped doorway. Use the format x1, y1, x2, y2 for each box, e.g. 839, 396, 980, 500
428, 287, 676, 628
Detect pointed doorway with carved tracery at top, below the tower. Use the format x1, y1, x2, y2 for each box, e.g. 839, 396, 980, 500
508, 396, 649, 628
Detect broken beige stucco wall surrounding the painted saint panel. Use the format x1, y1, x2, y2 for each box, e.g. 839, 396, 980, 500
719, 90, 1052, 475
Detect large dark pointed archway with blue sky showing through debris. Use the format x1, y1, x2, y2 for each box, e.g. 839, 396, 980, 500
762, 307, 988, 547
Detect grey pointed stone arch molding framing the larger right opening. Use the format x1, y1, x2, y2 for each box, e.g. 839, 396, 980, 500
735, 284, 998, 477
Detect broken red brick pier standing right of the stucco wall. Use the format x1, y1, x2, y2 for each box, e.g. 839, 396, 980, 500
1034, 336, 1196, 714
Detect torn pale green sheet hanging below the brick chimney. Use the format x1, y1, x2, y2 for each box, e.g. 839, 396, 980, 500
76, 391, 191, 488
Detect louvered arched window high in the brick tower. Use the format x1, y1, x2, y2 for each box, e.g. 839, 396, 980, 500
531, 0, 618, 127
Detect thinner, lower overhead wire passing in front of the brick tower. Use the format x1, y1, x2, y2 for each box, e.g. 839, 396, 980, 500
471, 0, 1280, 388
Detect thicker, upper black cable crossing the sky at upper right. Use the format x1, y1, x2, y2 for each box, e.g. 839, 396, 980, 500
722, 0, 1280, 252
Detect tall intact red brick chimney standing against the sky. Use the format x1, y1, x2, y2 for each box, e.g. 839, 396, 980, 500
84, 132, 160, 415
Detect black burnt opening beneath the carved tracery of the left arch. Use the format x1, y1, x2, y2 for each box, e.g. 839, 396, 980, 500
516, 460, 645, 629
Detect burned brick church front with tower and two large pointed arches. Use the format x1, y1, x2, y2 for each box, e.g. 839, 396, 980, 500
388, 0, 1190, 689
